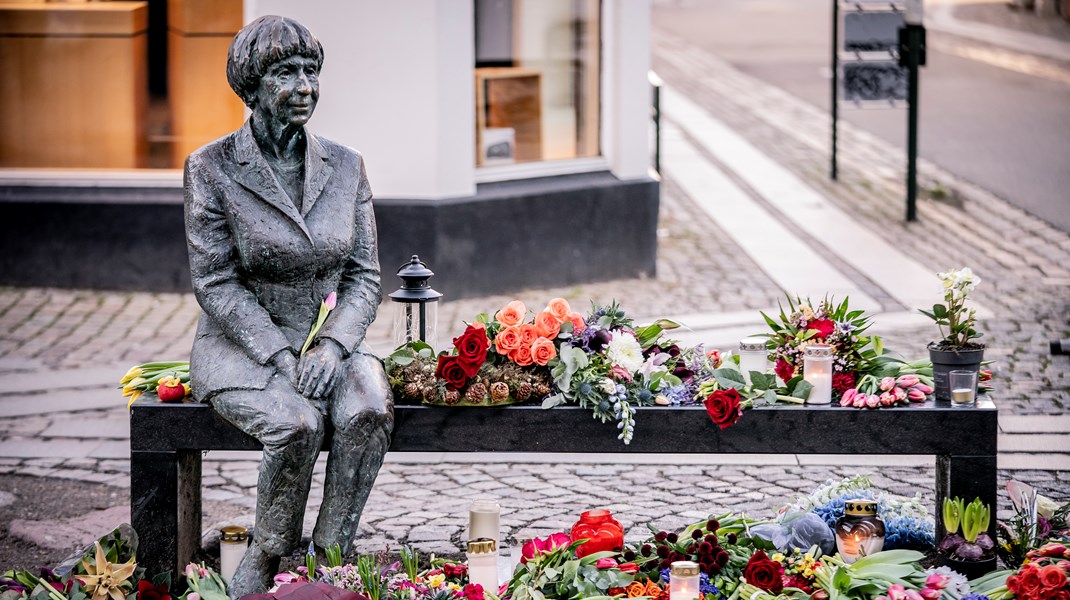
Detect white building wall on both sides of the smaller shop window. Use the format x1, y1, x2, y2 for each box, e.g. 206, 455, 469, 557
245, 0, 651, 199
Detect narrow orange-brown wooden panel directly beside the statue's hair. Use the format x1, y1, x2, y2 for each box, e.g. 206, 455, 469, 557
167, 0, 245, 167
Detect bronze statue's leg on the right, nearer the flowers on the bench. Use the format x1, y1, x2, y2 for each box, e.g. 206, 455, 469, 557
312, 353, 394, 554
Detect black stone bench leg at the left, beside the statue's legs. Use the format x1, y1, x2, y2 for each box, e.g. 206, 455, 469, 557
131, 451, 201, 578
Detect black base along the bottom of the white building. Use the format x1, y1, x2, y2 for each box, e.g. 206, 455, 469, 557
0, 172, 659, 299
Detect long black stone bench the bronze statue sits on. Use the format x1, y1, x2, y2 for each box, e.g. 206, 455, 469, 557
131, 396, 997, 573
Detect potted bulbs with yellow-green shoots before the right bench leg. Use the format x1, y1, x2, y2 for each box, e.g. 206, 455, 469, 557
936, 497, 996, 579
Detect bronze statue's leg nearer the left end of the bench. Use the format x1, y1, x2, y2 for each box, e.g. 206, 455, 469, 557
211, 375, 323, 598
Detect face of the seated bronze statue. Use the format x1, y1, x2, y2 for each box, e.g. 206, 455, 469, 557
254, 56, 320, 125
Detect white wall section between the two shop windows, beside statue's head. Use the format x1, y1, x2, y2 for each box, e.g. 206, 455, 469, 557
245, 0, 475, 198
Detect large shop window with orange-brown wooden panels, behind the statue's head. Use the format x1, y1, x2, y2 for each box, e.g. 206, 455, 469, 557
0, 0, 244, 169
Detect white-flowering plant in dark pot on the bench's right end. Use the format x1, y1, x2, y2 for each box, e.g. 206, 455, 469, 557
921, 268, 984, 401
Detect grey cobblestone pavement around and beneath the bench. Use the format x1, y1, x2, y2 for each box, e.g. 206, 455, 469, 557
0, 18, 1070, 568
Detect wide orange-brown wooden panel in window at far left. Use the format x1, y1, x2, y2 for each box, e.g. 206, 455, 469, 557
0, 2, 149, 169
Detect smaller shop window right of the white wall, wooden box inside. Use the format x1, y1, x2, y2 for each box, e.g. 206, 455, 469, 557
475, 0, 601, 167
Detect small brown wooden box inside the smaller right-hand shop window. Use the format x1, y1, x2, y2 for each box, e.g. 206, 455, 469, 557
475, 66, 542, 166
